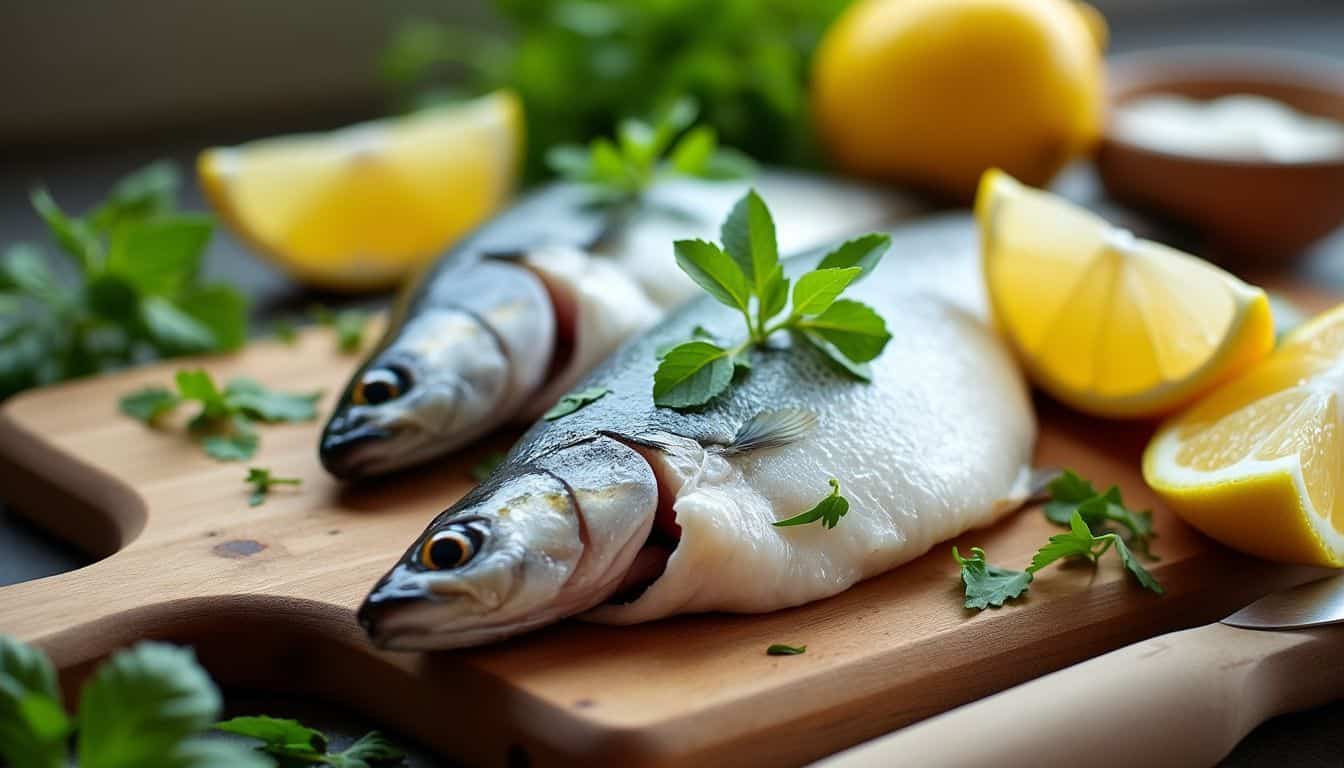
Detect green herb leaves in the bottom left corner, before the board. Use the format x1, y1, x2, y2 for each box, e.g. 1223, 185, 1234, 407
0, 635, 405, 768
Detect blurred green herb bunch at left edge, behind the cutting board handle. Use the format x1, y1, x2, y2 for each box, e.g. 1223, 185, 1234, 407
0, 163, 247, 398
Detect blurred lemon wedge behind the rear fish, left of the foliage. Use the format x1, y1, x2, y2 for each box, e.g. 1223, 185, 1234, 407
198, 91, 523, 291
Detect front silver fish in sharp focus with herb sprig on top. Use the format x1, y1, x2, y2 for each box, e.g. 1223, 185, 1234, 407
359, 217, 1035, 650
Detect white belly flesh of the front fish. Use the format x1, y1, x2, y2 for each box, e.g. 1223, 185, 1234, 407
586, 254, 1036, 624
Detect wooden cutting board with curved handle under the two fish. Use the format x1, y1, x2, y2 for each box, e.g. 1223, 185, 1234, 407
0, 306, 1316, 767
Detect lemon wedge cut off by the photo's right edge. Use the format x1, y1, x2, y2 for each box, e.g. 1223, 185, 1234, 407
1144, 305, 1344, 566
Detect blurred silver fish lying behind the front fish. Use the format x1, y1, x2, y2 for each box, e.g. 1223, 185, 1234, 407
319, 172, 914, 479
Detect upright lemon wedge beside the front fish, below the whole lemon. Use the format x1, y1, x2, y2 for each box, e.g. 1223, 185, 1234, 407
976, 171, 1274, 418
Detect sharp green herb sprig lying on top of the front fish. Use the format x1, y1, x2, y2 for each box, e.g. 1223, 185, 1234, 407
653, 190, 891, 409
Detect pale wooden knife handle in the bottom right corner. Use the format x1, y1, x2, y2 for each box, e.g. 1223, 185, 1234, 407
818, 624, 1344, 768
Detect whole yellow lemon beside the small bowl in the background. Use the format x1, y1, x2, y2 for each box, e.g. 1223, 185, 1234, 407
812, 0, 1106, 202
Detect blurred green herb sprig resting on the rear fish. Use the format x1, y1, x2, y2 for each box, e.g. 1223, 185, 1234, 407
546, 100, 755, 203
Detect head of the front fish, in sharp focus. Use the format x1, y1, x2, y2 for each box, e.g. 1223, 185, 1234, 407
358, 440, 659, 651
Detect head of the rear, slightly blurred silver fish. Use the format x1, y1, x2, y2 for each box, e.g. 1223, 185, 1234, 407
319, 309, 511, 479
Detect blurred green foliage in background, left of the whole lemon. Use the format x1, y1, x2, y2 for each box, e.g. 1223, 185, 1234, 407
383, 0, 849, 179
